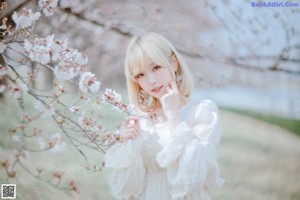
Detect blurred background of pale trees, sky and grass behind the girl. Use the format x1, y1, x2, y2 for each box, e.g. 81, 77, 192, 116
0, 0, 300, 200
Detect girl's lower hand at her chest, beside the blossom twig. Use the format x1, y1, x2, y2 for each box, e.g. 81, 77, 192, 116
122, 116, 141, 141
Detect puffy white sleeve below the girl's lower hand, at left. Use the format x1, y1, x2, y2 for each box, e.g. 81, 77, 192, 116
105, 138, 145, 200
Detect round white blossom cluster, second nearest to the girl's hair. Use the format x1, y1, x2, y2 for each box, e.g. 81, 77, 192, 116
79, 72, 100, 93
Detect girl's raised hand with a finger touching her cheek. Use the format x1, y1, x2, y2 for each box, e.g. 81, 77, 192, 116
160, 81, 181, 119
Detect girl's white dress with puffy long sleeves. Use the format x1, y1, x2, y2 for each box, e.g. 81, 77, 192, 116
105, 100, 223, 200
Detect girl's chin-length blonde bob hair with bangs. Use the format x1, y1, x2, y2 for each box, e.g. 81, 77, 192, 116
125, 33, 193, 112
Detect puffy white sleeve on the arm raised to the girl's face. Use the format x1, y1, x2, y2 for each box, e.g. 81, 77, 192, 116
156, 100, 223, 199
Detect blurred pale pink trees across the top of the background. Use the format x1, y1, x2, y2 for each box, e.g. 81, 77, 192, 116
2, 0, 300, 86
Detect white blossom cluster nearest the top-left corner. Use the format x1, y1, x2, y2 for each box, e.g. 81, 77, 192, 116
12, 8, 41, 29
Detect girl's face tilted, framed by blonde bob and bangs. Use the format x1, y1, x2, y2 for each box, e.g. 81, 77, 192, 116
134, 58, 175, 99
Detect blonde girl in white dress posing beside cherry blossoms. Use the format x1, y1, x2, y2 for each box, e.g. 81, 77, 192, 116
105, 33, 222, 200
